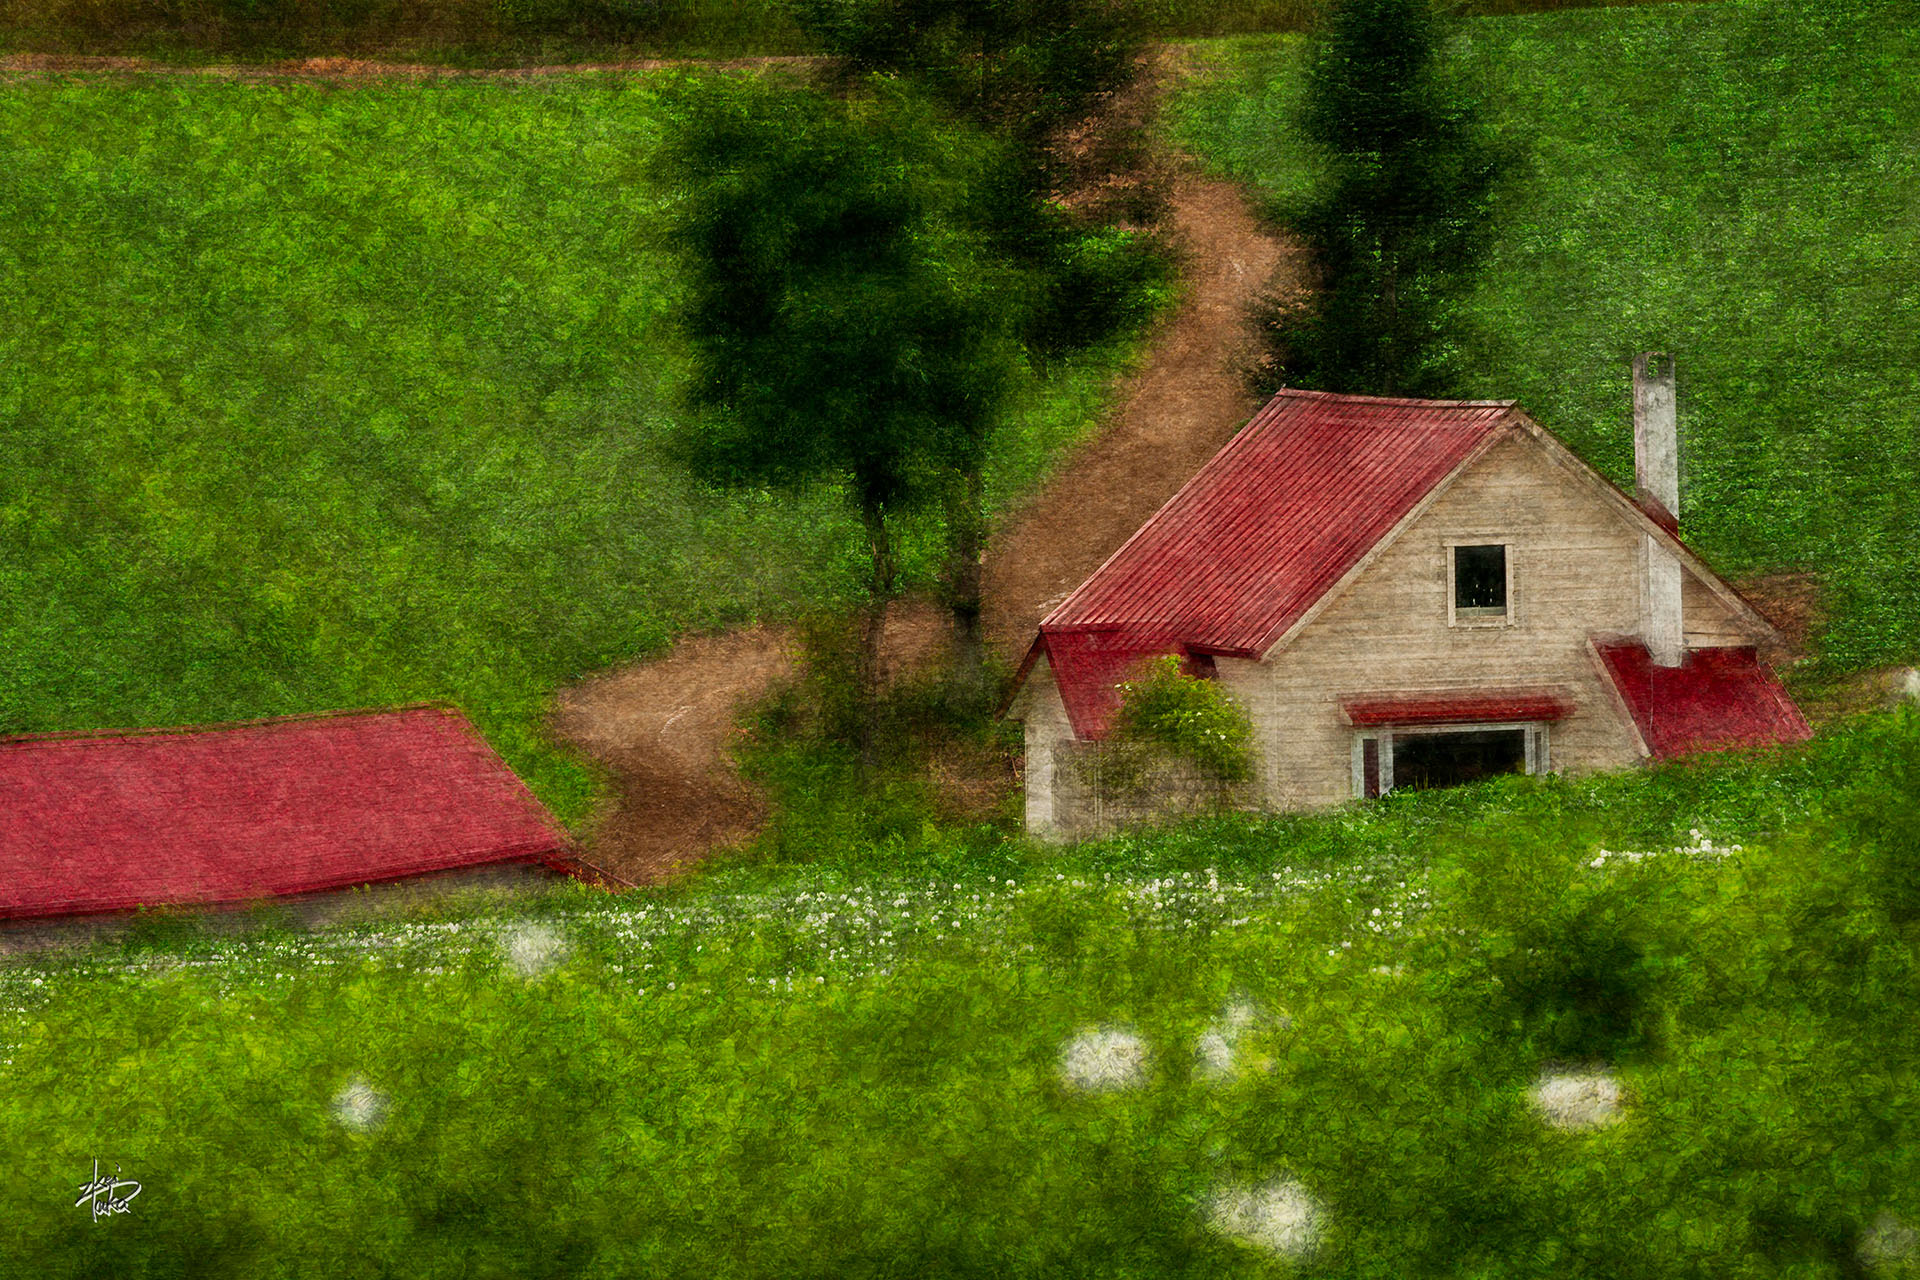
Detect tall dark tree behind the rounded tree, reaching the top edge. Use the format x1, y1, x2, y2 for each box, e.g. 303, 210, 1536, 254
791, 0, 1167, 689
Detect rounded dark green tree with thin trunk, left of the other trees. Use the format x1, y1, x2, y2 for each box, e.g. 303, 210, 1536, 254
662, 81, 1020, 762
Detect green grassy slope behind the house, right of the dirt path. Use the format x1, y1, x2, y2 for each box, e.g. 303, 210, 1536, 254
1177, 0, 1920, 668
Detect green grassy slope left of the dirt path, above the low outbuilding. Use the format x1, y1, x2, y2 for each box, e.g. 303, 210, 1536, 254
0, 77, 1116, 816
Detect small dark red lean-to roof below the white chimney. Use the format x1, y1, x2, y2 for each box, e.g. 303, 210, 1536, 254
1594, 637, 1812, 760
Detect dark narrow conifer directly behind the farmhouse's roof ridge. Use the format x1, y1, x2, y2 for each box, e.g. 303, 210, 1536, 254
1254, 0, 1513, 395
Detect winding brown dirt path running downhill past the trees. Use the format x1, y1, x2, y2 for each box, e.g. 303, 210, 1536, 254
553, 173, 1288, 883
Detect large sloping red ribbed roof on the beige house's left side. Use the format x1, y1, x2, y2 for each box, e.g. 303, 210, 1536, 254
1041, 391, 1513, 737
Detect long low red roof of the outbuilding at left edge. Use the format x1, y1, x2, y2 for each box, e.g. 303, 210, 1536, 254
0, 706, 606, 919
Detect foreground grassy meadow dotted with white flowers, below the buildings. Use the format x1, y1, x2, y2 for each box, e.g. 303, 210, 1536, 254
0, 712, 1920, 1280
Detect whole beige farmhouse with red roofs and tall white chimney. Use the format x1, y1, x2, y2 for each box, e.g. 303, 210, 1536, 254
1008, 357, 1809, 835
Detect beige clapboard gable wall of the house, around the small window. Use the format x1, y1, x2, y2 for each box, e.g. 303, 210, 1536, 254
1219, 436, 1736, 808
